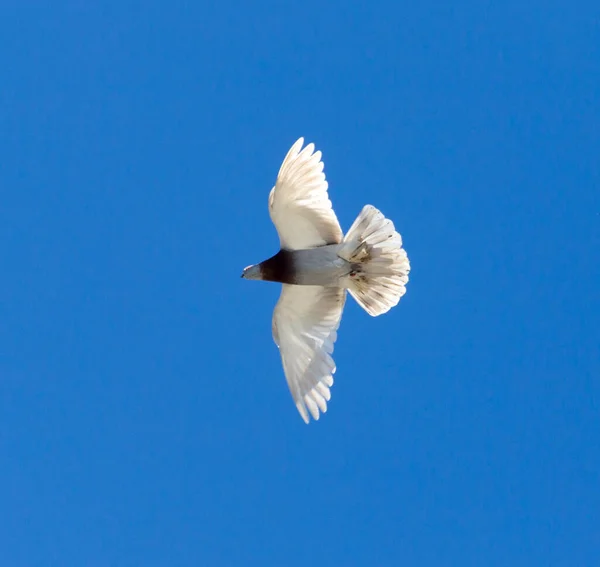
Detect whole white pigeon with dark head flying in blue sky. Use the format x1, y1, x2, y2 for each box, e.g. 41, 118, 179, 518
242, 138, 410, 424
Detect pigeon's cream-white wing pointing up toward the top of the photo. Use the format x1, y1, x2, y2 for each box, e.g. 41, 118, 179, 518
269, 138, 343, 250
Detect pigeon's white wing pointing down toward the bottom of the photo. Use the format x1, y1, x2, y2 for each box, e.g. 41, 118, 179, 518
273, 284, 346, 423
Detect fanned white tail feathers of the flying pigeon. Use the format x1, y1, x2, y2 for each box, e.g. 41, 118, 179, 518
338, 205, 410, 317
